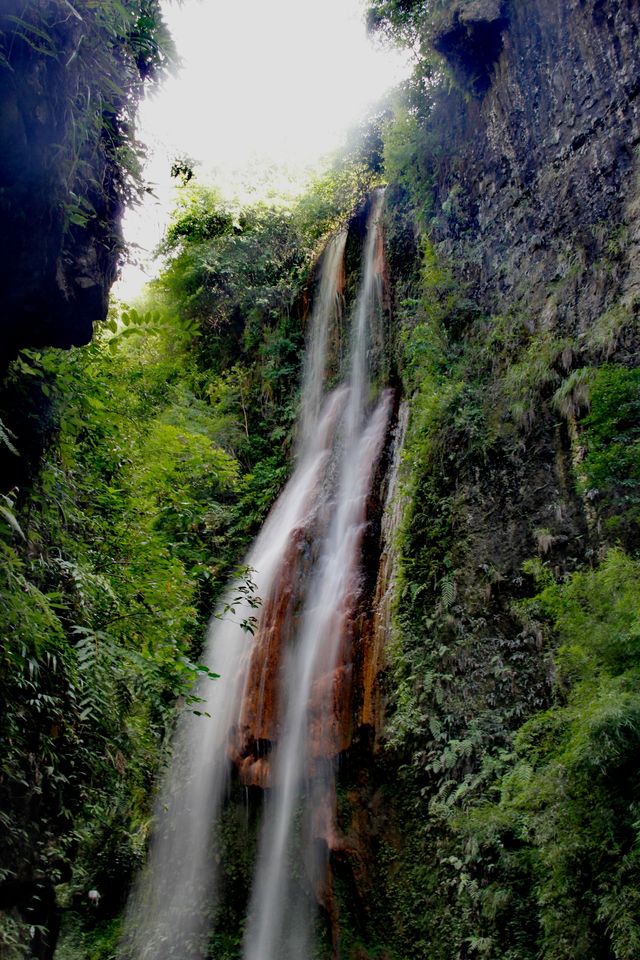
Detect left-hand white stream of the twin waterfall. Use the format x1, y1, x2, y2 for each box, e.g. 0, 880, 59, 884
124, 223, 346, 960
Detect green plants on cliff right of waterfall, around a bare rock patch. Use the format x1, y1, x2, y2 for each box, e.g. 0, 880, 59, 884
380, 245, 640, 960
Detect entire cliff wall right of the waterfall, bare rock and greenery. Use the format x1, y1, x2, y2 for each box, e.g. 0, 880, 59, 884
335, 0, 640, 960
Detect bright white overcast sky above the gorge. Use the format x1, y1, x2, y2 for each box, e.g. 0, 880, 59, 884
114, 0, 407, 299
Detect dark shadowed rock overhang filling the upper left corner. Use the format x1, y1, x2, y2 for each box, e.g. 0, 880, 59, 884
0, 0, 167, 364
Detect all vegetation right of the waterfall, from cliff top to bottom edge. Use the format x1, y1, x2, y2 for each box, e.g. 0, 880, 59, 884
352, 3, 640, 960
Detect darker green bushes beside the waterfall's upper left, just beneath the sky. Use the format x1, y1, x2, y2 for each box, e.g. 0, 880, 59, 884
150, 176, 382, 543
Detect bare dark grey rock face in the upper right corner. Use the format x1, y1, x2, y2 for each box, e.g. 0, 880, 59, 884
434, 0, 640, 333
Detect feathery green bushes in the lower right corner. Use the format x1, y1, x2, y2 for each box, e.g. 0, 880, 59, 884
380, 550, 640, 960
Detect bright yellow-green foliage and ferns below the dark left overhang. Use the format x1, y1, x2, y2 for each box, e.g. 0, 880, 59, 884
0, 310, 248, 936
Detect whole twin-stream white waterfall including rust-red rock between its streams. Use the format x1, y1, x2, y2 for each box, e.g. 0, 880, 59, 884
125, 192, 392, 960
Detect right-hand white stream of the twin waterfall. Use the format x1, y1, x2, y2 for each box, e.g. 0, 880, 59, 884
244, 189, 391, 960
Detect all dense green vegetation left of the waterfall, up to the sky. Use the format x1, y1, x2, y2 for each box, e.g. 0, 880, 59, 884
0, 165, 378, 958
